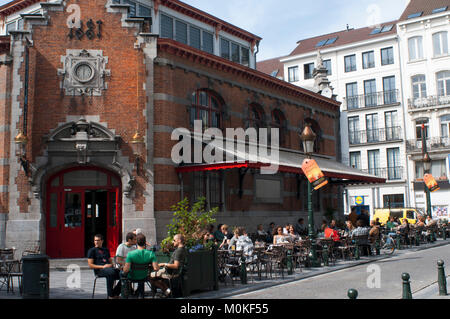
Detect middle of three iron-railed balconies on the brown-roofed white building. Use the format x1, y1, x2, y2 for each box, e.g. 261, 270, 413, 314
348, 126, 402, 145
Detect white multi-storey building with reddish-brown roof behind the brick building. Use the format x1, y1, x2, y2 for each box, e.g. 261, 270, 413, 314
281, 23, 409, 214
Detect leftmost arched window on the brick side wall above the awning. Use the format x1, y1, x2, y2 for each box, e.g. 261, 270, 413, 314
190, 90, 222, 129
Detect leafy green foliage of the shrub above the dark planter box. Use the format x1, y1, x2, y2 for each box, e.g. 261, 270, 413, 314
161, 197, 219, 252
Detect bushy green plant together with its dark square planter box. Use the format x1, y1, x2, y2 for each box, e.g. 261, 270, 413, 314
157, 197, 219, 295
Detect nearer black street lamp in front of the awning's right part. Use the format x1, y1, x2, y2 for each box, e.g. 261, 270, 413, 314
300, 123, 320, 267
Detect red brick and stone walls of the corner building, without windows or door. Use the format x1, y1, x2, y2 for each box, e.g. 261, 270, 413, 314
0, 0, 339, 256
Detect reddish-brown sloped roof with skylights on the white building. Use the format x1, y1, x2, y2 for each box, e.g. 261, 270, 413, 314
289, 21, 398, 56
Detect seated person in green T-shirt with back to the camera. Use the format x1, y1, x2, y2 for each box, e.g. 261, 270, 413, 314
123, 234, 159, 298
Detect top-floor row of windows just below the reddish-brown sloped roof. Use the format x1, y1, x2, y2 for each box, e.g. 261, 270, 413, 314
288, 47, 394, 82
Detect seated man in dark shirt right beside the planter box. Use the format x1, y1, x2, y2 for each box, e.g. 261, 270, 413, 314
150, 234, 187, 297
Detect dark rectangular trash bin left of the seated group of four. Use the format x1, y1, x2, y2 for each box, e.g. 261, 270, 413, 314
22, 255, 50, 299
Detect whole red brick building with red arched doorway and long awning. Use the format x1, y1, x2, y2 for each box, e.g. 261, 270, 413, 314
0, 0, 380, 257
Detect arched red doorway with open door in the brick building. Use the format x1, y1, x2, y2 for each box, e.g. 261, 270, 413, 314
46, 166, 122, 258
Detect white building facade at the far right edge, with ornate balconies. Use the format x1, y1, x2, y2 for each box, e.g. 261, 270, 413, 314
398, 5, 450, 218
